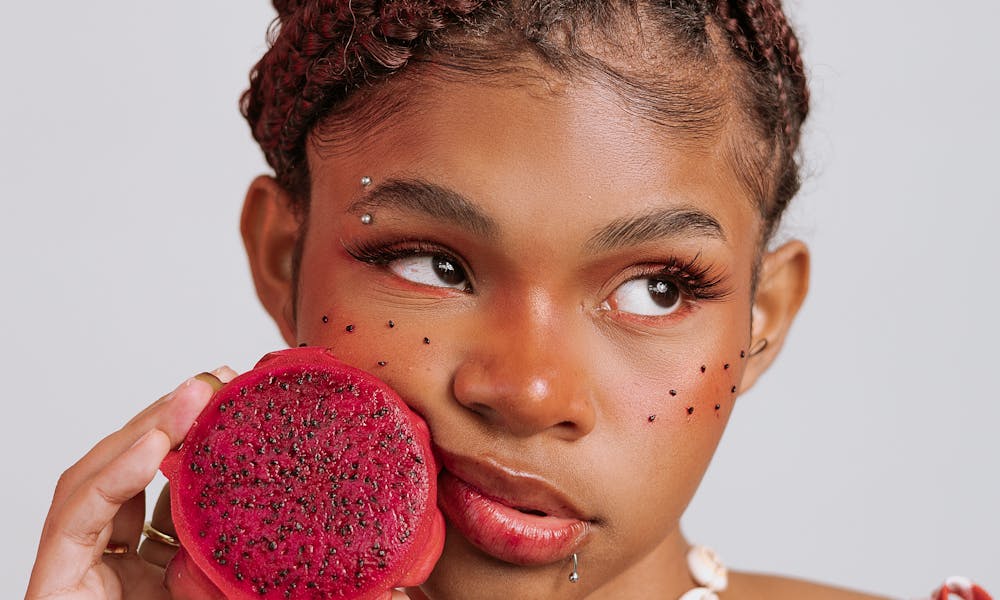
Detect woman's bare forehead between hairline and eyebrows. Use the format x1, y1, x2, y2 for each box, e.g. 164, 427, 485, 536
308, 77, 758, 251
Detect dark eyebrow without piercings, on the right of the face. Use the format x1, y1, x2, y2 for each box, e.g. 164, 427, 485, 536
586, 207, 726, 252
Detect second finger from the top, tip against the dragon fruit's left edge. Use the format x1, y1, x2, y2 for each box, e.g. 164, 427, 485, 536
29, 429, 171, 595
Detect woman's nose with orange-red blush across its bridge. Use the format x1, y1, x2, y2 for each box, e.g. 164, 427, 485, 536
453, 302, 596, 440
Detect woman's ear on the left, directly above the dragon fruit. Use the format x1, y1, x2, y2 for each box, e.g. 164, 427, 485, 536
240, 175, 301, 346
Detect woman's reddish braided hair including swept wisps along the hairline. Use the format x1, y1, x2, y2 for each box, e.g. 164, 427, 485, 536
241, 0, 809, 242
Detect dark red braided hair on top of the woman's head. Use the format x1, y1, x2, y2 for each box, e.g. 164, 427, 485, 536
241, 0, 809, 239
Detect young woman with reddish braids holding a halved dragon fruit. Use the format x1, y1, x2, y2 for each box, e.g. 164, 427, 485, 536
28, 0, 987, 600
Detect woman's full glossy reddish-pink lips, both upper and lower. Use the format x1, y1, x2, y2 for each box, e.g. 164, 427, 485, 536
438, 449, 592, 566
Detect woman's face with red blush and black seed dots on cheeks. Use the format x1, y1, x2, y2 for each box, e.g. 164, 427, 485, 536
244, 69, 788, 598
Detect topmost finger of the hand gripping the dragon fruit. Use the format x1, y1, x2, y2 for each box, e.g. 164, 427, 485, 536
52, 377, 219, 509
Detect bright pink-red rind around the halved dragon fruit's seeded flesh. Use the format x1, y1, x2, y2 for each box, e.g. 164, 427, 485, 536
161, 347, 444, 600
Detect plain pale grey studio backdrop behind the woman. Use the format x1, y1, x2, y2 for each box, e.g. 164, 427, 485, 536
0, 0, 1000, 598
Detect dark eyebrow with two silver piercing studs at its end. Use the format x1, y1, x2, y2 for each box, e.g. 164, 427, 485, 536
347, 179, 500, 238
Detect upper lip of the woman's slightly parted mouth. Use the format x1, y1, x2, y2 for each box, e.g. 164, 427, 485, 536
435, 447, 593, 521
